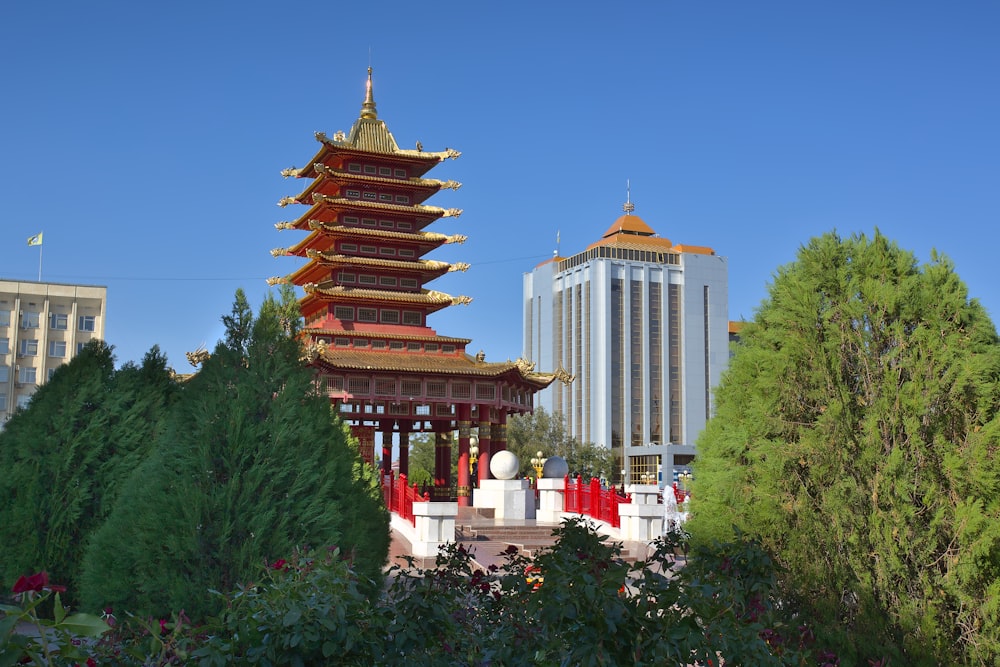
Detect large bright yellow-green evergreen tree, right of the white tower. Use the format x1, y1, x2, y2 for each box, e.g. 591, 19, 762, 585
688, 232, 1000, 665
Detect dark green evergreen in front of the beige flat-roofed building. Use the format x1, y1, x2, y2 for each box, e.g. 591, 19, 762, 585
0, 340, 174, 599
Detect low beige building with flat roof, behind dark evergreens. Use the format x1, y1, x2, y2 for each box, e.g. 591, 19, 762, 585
0, 280, 108, 424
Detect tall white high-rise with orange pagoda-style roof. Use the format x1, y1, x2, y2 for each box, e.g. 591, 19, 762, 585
523, 203, 729, 483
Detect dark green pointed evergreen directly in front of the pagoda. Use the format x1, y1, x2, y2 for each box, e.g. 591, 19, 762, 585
82, 291, 389, 616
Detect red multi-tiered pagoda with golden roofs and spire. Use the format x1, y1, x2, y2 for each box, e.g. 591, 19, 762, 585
270, 68, 556, 505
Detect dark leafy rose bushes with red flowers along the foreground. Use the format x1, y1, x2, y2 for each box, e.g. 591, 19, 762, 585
0, 520, 887, 667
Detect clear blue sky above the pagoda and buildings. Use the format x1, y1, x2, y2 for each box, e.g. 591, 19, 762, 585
0, 0, 1000, 372
